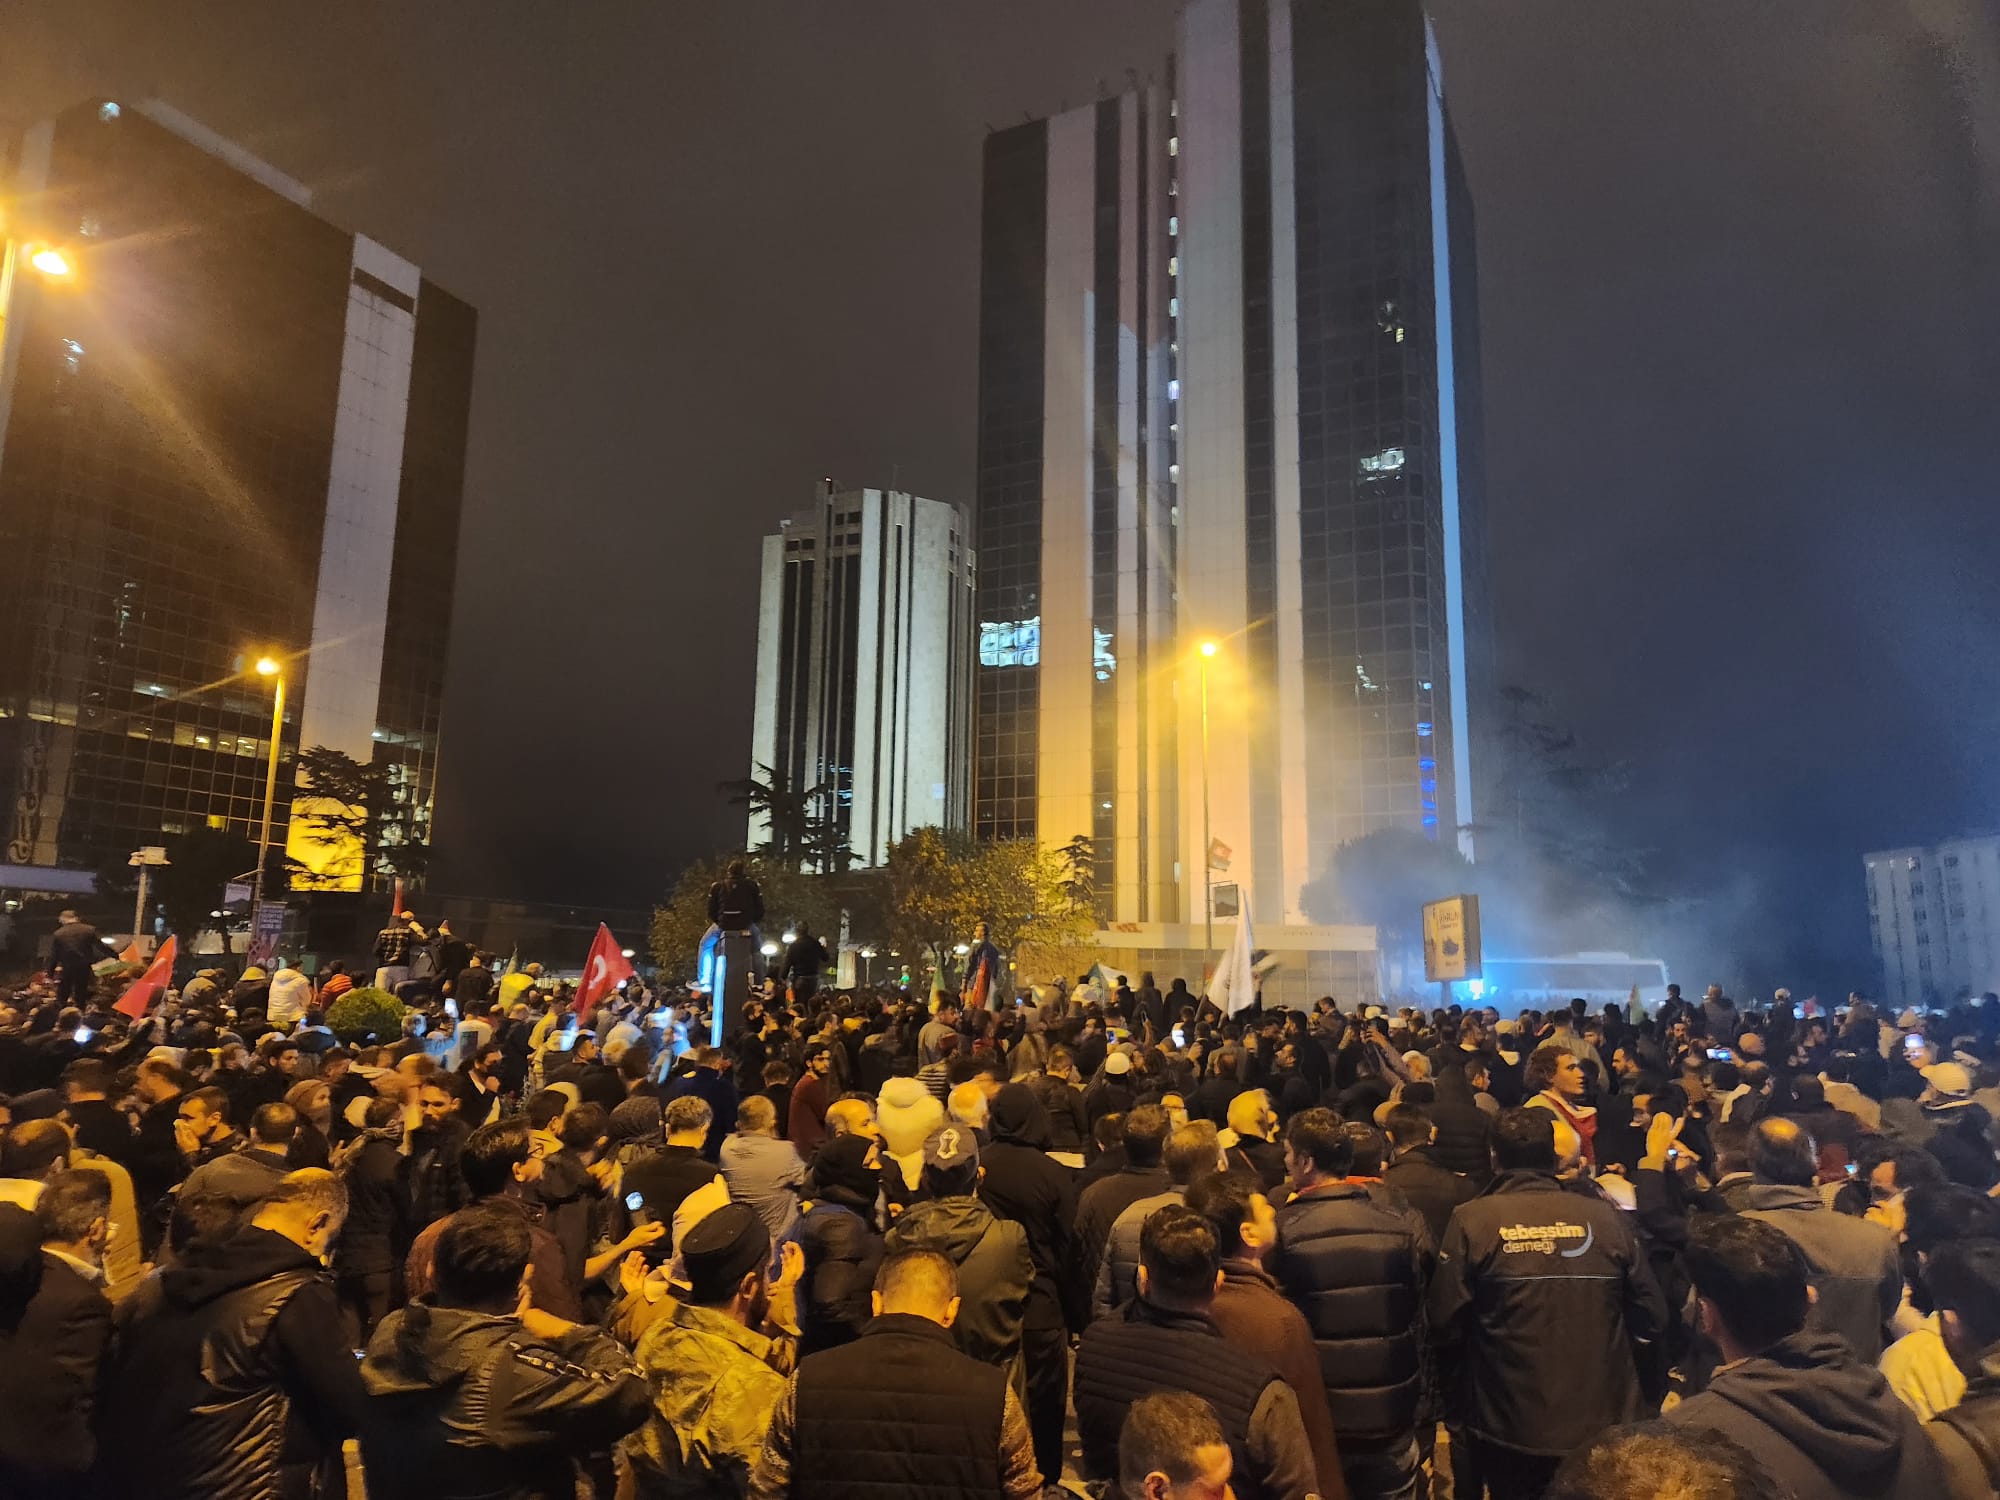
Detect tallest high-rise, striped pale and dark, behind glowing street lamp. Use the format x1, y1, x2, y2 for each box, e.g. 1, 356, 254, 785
972, 0, 1490, 964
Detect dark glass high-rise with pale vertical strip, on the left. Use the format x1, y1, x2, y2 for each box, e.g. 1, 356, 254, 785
0, 100, 476, 888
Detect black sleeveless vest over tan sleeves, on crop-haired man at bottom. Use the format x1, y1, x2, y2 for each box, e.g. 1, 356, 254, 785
772, 1314, 1006, 1500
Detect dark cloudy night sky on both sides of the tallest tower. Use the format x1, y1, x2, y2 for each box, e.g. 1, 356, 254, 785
0, 0, 2000, 1000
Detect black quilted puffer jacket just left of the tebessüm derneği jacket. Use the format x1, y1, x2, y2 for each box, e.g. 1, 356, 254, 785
1272, 1182, 1434, 1446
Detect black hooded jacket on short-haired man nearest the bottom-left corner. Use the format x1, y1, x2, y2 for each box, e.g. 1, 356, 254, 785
98, 1226, 362, 1500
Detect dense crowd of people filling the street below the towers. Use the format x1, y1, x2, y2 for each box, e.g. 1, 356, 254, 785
0, 916, 2000, 1500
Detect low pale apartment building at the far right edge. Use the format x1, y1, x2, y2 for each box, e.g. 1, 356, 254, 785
1862, 834, 2000, 1010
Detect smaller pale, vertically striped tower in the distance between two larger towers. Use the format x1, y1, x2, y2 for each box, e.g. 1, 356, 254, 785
748, 480, 974, 866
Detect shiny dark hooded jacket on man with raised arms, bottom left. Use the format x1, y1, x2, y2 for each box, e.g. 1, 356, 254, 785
362, 1302, 652, 1500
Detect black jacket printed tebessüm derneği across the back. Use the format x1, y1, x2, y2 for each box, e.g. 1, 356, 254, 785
1430, 1172, 1666, 1456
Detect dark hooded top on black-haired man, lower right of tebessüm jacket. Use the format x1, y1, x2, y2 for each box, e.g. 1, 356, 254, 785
1666, 1332, 1944, 1500
